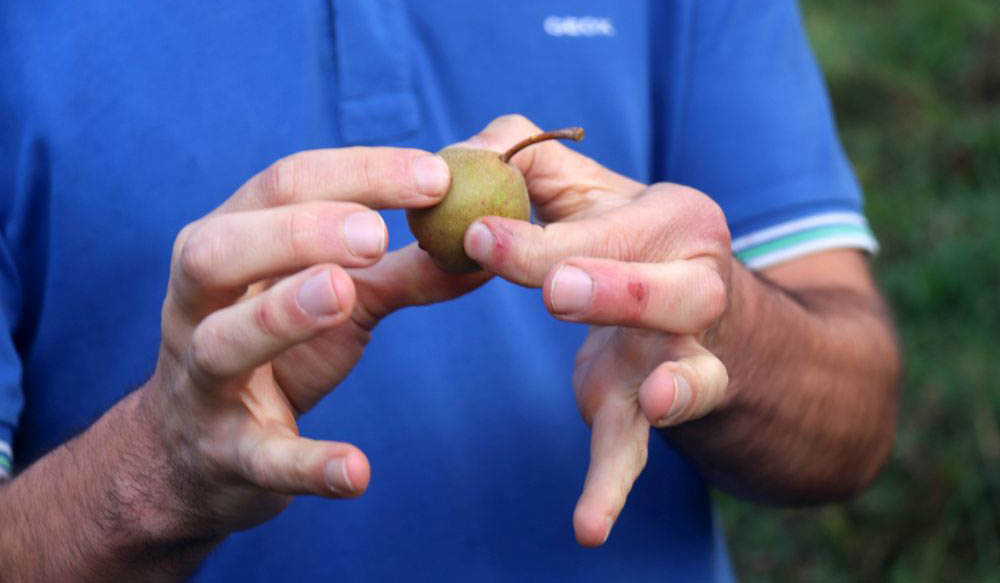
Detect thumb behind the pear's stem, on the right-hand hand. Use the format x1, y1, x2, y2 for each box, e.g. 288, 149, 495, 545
464, 115, 643, 222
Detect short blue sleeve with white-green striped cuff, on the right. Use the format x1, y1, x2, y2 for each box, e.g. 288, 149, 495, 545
661, 0, 878, 269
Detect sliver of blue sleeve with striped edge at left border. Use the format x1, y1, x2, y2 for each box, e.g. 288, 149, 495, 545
0, 235, 24, 479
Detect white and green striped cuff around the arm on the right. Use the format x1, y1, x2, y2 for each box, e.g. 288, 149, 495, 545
732, 212, 878, 269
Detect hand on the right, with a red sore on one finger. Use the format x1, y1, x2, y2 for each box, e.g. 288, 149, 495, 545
465, 116, 732, 546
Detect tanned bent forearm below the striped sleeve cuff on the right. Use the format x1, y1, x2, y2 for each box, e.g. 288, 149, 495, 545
665, 258, 900, 504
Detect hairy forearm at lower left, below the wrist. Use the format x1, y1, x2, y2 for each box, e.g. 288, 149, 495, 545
0, 394, 219, 581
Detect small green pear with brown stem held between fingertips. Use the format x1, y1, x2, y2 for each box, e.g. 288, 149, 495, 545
406, 128, 583, 273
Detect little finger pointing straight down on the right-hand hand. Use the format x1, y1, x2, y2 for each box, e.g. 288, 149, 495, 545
573, 400, 649, 547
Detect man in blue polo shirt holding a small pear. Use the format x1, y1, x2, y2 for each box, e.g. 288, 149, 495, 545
0, 0, 898, 581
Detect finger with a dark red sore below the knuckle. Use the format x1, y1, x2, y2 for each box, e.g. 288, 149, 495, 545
543, 257, 726, 334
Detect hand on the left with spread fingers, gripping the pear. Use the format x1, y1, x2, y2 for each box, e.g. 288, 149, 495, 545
135, 148, 488, 533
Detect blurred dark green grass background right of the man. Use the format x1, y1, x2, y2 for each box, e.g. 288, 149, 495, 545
719, 0, 1000, 583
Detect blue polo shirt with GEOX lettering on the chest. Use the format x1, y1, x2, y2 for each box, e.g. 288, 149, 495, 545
0, 0, 874, 582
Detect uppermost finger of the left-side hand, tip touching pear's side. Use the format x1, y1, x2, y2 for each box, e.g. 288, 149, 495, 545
221, 147, 451, 213
